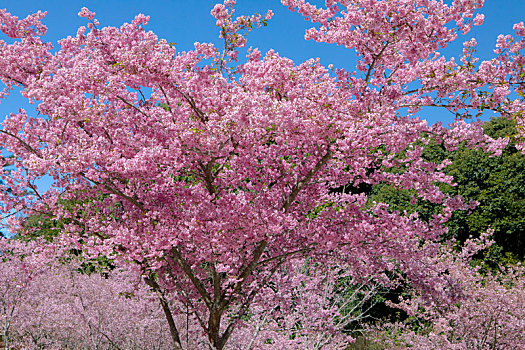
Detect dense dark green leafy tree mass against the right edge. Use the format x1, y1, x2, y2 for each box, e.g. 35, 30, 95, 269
447, 118, 525, 259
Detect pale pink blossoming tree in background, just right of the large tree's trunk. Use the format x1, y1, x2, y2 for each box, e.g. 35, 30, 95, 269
227, 260, 387, 350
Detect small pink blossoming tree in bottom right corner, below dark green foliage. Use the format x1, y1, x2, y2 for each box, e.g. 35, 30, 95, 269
378, 232, 525, 350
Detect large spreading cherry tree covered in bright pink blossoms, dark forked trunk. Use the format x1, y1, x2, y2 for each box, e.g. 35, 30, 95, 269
0, 0, 525, 349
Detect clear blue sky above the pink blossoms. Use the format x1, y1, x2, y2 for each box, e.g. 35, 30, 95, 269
0, 0, 525, 123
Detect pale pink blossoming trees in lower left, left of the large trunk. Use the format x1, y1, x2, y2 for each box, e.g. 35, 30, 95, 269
0, 239, 176, 349
